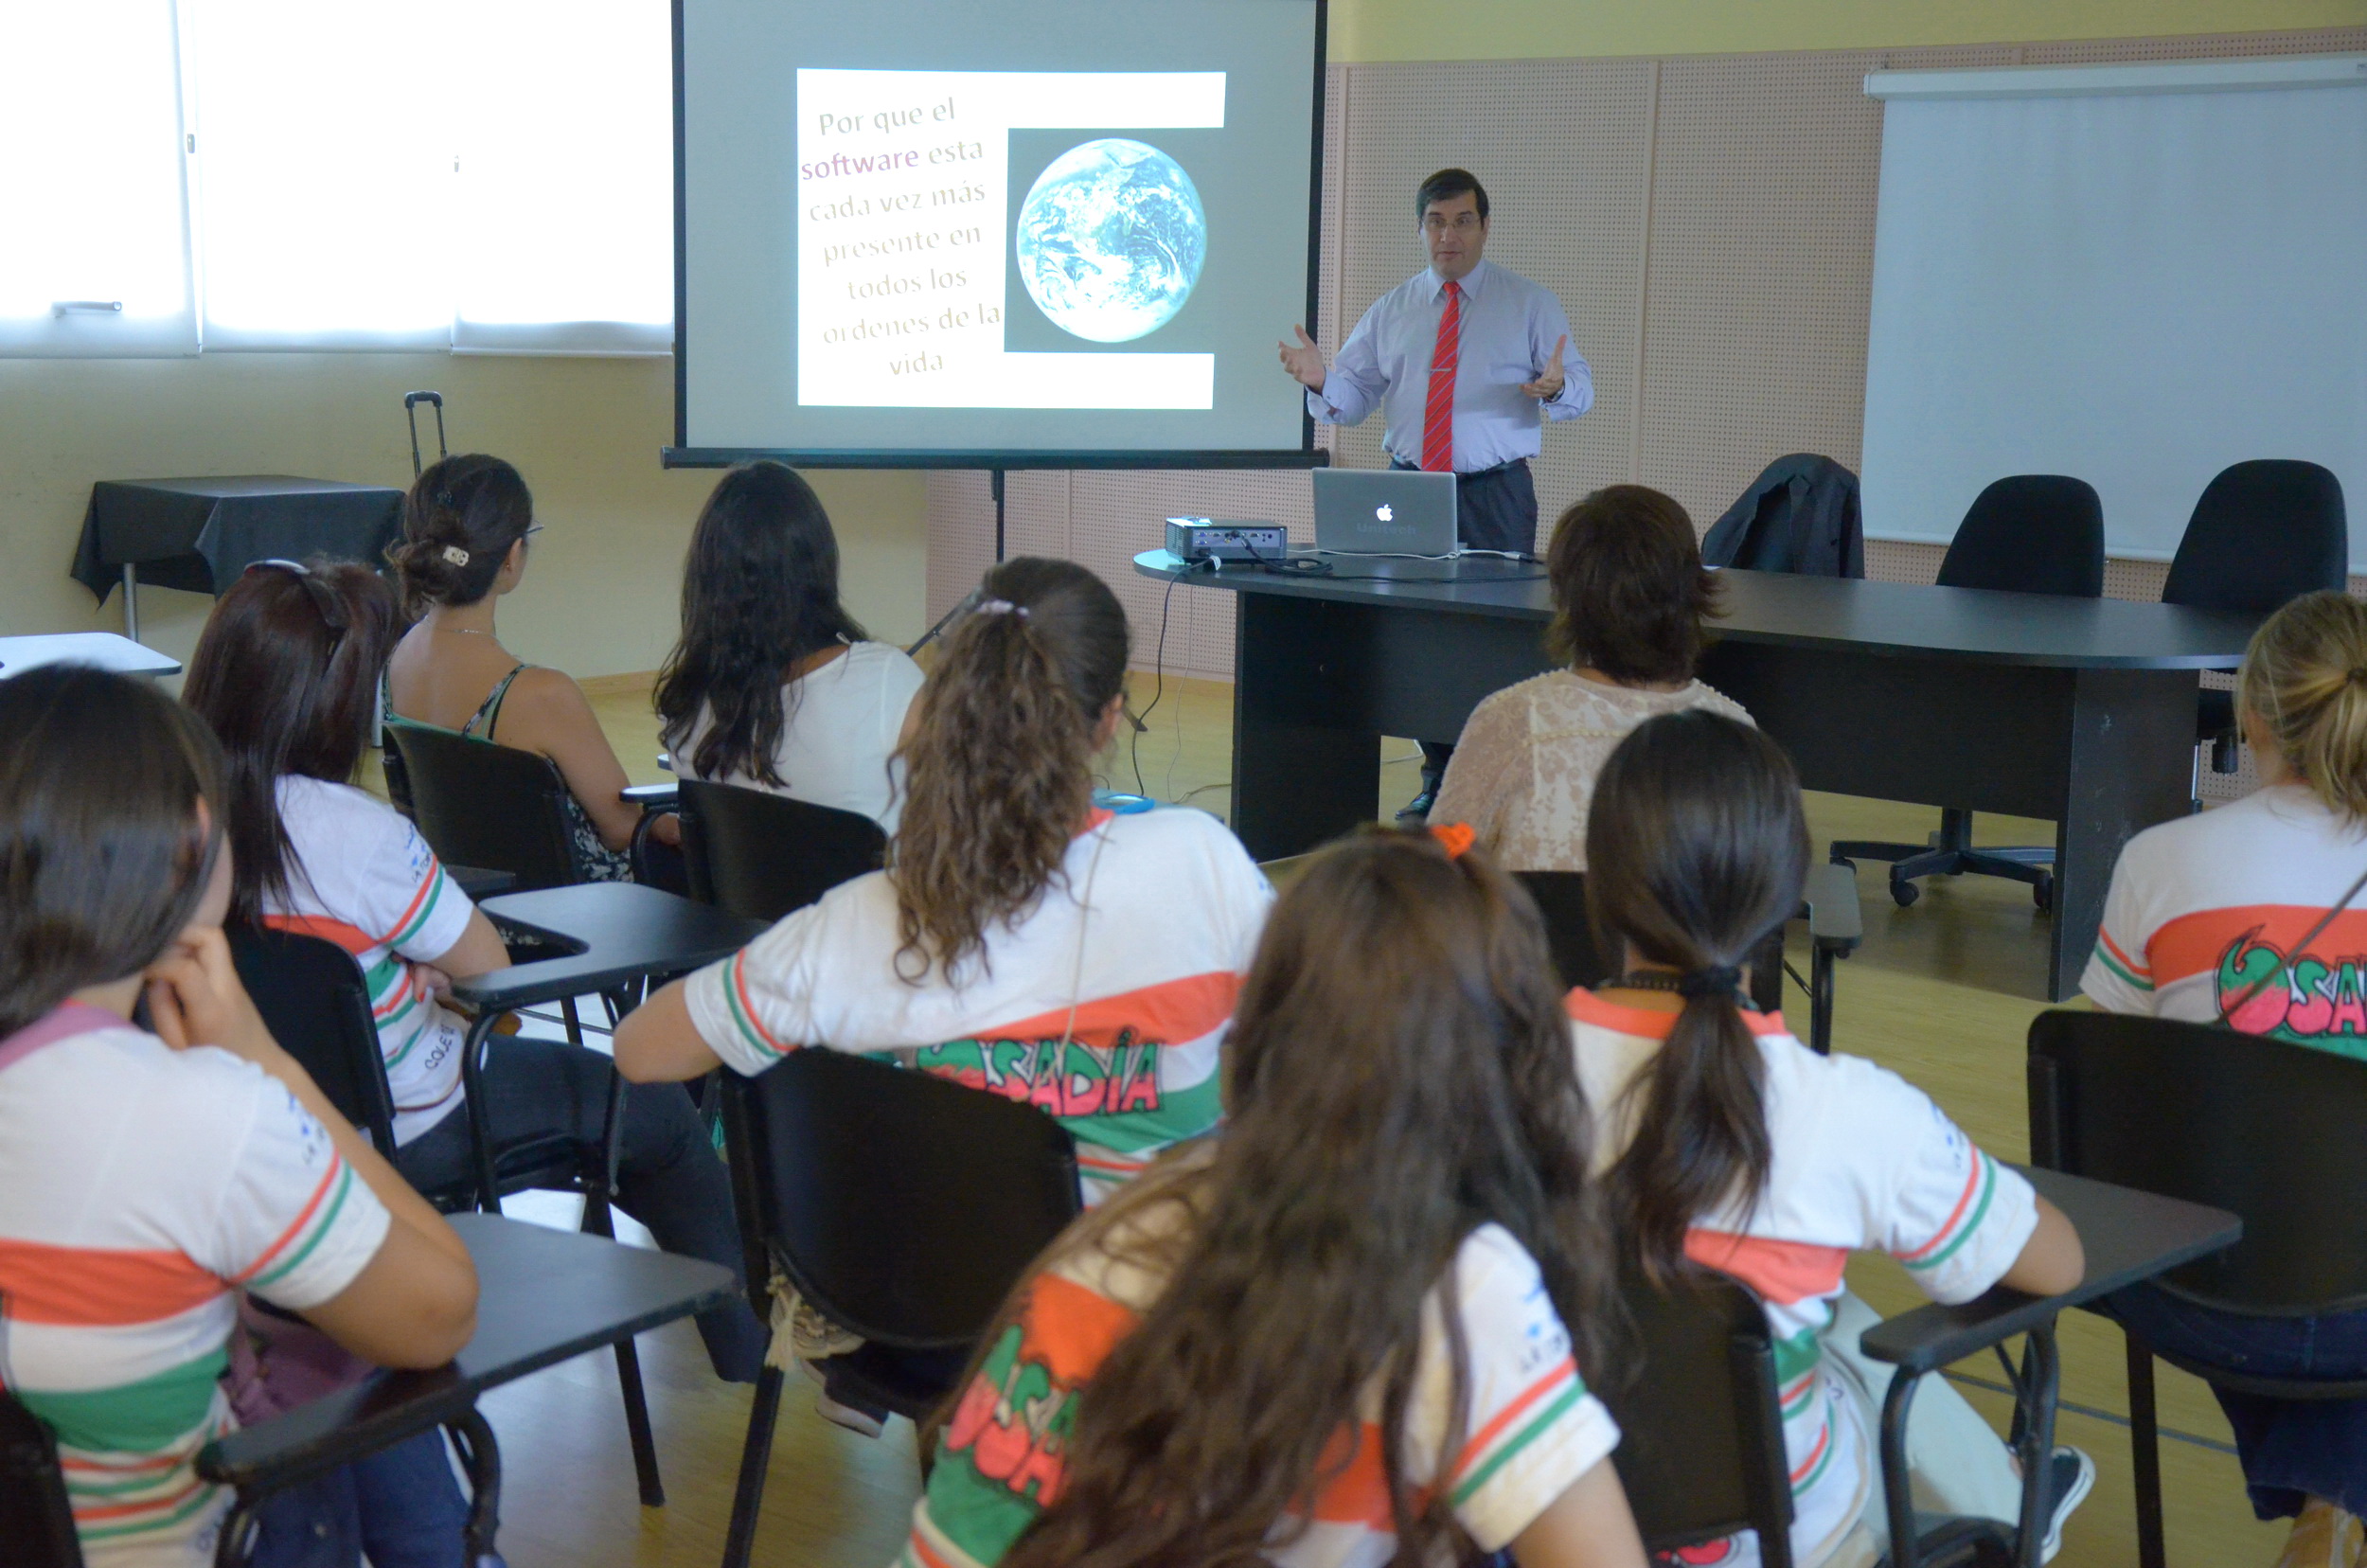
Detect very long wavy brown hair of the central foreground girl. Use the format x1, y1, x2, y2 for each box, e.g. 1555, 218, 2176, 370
973, 829, 1610, 1568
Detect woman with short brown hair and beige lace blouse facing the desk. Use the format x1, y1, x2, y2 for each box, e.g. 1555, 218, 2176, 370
1430, 486, 1750, 872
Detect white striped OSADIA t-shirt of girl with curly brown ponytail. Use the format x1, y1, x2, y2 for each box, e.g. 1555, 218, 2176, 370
686, 811, 1273, 1201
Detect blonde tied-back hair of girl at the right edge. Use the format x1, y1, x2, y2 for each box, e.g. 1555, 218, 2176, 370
2234, 590, 2367, 822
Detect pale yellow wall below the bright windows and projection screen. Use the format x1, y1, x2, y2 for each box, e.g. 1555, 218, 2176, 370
0, 353, 928, 675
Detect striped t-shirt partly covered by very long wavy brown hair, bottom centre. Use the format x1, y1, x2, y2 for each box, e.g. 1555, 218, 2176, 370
898, 1224, 1619, 1568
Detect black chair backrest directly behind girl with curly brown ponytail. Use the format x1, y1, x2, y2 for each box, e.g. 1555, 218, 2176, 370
724, 1047, 1079, 1350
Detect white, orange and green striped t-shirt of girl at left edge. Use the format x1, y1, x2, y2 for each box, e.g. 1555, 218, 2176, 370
0, 1005, 388, 1568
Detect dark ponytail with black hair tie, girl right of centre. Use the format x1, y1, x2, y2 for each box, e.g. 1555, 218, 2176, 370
1586, 708, 1808, 1276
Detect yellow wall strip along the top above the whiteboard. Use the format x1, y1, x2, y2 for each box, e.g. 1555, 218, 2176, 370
1330, 0, 2367, 62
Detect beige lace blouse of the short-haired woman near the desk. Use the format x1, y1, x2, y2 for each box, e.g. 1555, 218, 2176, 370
1430, 670, 1752, 872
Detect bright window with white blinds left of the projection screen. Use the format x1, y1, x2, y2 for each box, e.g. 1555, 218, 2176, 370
0, 0, 675, 355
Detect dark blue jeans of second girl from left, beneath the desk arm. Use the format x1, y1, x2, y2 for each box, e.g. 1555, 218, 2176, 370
396, 1035, 767, 1383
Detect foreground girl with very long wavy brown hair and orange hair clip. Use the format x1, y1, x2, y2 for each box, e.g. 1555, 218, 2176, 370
898, 829, 1646, 1568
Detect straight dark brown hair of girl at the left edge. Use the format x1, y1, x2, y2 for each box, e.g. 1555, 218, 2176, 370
0, 666, 222, 1038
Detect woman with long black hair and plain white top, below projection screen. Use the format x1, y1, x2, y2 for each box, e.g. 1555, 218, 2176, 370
656, 462, 921, 834
